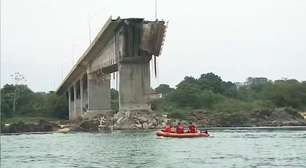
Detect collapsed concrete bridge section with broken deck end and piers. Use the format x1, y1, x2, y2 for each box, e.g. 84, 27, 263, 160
56, 18, 166, 120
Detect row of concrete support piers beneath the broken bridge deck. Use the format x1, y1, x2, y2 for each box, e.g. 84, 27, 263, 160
67, 62, 151, 119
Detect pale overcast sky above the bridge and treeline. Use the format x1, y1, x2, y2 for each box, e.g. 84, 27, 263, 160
1, 0, 306, 91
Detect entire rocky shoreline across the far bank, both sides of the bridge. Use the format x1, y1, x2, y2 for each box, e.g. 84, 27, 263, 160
1, 108, 306, 133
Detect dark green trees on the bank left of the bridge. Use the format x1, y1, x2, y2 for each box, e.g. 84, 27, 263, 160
1, 84, 68, 119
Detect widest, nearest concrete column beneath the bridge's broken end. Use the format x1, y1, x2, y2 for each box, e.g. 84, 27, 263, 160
119, 63, 151, 111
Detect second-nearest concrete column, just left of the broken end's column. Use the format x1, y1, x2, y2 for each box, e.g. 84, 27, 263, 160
86, 73, 111, 116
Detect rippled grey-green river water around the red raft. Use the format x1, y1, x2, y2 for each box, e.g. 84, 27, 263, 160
1, 128, 306, 168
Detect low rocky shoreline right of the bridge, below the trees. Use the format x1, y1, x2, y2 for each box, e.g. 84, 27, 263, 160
185, 107, 306, 127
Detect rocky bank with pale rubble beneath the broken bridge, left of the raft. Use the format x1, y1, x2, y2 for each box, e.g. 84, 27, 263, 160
1, 110, 167, 133
